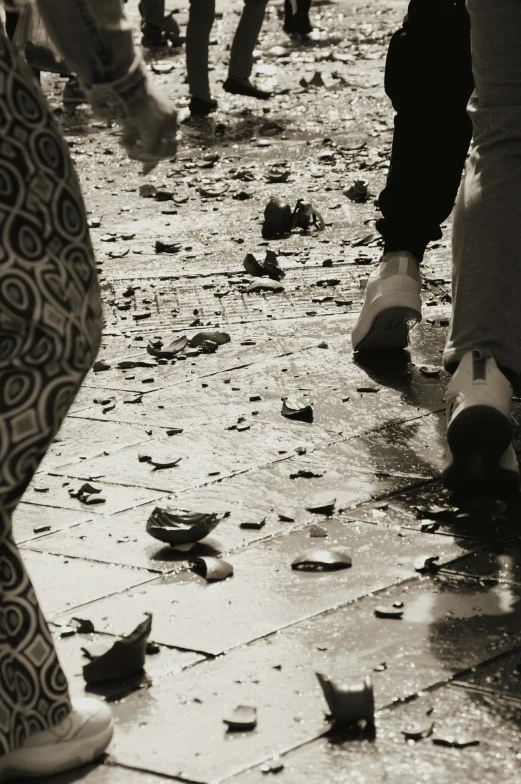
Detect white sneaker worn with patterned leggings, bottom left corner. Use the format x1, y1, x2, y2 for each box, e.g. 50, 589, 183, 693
0, 697, 113, 781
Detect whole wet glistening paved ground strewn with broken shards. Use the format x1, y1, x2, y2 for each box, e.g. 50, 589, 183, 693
10, 0, 521, 784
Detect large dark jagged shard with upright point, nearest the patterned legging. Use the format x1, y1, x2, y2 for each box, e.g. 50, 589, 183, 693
82, 615, 152, 684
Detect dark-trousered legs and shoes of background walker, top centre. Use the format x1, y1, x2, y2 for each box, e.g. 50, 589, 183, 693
186, 0, 271, 116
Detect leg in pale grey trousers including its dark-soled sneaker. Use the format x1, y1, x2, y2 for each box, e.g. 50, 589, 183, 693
444, 0, 521, 488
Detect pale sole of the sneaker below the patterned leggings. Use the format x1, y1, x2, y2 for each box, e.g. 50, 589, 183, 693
0, 723, 114, 781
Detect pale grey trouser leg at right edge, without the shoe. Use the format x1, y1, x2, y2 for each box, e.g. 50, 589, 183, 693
444, 0, 521, 374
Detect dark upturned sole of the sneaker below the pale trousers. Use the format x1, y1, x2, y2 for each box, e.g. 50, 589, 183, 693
442, 406, 519, 495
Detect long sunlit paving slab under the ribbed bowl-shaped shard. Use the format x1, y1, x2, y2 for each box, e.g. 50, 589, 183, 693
21, 450, 426, 572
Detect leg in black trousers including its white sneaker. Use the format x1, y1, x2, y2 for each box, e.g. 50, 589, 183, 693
351, 0, 473, 351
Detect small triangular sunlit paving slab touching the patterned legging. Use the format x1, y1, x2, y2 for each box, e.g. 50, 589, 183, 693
21, 547, 152, 625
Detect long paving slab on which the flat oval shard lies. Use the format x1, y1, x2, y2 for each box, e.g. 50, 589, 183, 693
55, 515, 476, 655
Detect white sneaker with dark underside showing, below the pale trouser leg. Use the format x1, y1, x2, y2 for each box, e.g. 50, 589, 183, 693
442, 349, 519, 495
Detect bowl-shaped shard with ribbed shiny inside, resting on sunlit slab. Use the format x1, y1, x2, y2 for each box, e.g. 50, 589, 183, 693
147, 506, 230, 546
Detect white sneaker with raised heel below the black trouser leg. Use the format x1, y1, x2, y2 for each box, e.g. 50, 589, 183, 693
351, 251, 421, 351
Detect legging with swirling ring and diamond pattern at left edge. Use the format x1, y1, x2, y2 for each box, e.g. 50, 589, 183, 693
0, 33, 101, 754
